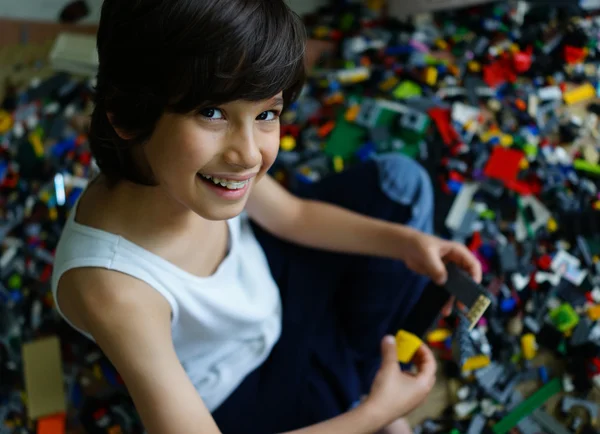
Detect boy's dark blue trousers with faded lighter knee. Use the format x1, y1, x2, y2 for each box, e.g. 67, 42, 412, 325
213, 154, 433, 434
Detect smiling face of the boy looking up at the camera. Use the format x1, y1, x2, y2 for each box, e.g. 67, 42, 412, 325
144, 93, 283, 220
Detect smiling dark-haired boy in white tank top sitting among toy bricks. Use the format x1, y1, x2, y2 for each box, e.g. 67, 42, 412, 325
52, 0, 481, 434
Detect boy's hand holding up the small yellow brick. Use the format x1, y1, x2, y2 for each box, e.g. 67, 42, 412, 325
365, 336, 437, 426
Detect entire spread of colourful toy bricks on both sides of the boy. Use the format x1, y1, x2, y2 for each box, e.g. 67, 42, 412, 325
0, 2, 600, 434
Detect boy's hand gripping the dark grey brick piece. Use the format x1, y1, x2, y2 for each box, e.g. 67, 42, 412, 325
401, 231, 481, 285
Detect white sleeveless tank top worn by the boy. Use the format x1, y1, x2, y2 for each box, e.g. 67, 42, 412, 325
52, 197, 281, 411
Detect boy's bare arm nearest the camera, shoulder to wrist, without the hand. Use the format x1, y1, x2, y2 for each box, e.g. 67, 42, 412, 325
58, 268, 418, 434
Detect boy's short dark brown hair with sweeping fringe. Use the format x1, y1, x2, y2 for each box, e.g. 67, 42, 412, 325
90, 0, 306, 184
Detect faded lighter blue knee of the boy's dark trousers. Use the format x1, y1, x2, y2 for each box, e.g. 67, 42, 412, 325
375, 153, 434, 232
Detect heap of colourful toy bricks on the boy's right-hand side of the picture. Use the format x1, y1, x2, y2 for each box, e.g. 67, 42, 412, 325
274, 3, 600, 434
